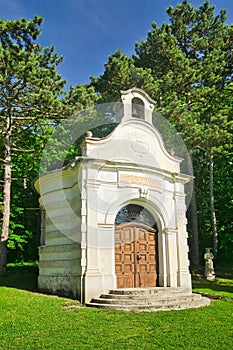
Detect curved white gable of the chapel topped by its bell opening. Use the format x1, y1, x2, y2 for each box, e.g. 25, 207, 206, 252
83, 88, 182, 173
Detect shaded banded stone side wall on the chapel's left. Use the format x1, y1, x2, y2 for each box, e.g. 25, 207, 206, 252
35, 168, 82, 299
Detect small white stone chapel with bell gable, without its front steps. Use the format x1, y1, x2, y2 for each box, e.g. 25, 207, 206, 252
35, 88, 209, 303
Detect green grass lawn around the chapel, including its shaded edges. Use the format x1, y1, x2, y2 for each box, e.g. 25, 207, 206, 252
0, 268, 233, 350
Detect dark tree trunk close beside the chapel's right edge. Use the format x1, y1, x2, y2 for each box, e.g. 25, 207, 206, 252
190, 188, 199, 269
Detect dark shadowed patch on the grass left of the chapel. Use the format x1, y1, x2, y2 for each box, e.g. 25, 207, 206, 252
0, 263, 38, 291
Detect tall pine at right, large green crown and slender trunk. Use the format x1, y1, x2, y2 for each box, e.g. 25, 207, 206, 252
136, 0, 233, 262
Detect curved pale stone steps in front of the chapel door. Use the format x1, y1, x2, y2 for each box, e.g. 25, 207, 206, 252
86, 287, 210, 311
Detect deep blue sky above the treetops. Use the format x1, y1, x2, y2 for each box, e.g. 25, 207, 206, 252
0, 0, 233, 86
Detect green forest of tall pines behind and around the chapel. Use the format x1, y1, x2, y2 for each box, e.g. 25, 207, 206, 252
0, 0, 233, 273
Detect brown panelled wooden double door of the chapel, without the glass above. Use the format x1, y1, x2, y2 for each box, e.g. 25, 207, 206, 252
115, 222, 157, 288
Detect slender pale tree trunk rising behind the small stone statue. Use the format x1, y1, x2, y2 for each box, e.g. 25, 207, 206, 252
210, 155, 218, 258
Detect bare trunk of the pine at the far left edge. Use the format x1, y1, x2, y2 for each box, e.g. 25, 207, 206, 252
0, 115, 12, 275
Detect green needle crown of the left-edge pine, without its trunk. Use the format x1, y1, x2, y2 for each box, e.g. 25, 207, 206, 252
0, 16, 65, 120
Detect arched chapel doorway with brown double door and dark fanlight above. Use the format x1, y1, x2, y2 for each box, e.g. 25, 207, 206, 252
115, 204, 158, 288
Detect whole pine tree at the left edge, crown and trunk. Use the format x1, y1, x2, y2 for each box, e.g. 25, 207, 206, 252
0, 16, 65, 274
